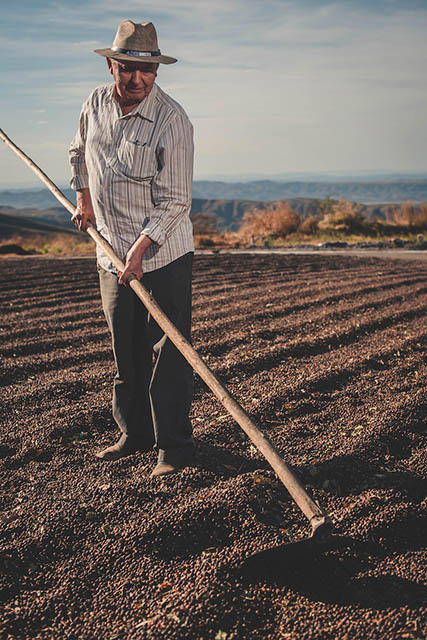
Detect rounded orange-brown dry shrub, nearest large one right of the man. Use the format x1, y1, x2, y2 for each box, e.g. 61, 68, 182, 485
239, 201, 300, 241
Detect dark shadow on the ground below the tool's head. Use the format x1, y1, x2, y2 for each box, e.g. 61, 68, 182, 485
236, 536, 427, 609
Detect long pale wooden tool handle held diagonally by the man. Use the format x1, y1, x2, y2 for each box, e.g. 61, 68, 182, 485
0, 129, 329, 534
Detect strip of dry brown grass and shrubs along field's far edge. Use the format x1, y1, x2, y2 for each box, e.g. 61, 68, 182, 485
0, 199, 427, 256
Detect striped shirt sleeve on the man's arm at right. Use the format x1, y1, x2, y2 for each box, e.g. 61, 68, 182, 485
141, 114, 194, 246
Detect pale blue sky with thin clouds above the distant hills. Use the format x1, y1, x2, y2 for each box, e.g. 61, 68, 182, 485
0, 0, 427, 189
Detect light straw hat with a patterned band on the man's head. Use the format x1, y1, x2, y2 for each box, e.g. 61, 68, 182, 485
94, 20, 176, 64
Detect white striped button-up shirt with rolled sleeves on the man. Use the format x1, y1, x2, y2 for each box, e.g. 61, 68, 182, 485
69, 84, 194, 273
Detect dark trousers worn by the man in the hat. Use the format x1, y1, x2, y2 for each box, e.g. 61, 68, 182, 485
98, 253, 194, 464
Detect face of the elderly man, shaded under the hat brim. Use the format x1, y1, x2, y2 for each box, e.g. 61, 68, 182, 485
107, 58, 159, 105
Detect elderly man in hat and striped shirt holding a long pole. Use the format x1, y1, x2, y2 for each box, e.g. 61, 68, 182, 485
70, 20, 194, 477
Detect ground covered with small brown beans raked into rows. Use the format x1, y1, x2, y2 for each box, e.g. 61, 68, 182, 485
0, 255, 427, 640
